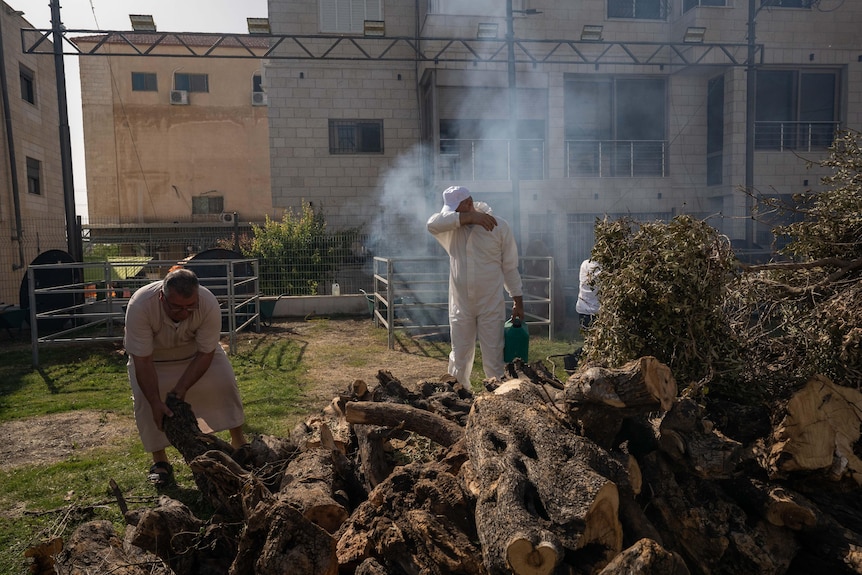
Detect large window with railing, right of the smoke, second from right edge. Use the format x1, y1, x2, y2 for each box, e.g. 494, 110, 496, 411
564, 75, 667, 178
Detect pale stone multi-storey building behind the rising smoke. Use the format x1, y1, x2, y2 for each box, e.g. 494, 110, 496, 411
265, 0, 862, 287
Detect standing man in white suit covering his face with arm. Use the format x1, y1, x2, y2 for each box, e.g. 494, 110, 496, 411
427, 186, 524, 388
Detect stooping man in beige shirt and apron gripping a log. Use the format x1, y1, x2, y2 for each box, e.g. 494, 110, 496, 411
125, 269, 246, 486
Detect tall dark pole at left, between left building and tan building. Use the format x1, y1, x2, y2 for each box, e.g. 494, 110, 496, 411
51, 0, 84, 262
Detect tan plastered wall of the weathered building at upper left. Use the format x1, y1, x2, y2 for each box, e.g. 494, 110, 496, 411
79, 40, 281, 224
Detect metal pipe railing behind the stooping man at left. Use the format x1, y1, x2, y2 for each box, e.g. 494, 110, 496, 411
26, 259, 260, 366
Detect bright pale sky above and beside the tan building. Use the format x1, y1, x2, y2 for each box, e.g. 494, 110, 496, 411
21, 0, 267, 222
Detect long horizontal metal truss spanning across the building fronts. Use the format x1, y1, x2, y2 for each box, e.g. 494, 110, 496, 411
21, 28, 763, 67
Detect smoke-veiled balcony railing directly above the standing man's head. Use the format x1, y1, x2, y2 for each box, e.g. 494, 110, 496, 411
437, 138, 545, 181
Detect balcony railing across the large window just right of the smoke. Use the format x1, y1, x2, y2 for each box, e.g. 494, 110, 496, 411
566, 140, 667, 178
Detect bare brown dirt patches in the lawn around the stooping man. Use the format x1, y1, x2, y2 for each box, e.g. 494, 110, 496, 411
0, 319, 449, 469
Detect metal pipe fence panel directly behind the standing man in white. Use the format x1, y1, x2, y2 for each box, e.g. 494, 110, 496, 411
366, 257, 554, 349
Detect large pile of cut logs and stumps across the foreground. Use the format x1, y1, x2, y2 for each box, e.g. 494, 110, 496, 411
38, 357, 862, 575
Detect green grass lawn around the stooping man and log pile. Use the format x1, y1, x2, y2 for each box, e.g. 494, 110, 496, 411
0, 319, 580, 574
